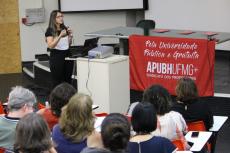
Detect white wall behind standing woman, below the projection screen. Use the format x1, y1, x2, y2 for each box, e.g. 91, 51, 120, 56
19, 0, 136, 61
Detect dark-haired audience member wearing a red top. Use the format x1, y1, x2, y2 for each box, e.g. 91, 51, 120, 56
37, 83, 77, 130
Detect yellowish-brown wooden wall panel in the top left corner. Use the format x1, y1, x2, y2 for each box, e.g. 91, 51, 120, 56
0, 0, 21, 74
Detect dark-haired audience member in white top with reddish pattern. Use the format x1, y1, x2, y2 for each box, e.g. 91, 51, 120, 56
143, 85, 187, 140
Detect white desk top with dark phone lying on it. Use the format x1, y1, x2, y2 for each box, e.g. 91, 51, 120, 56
185, 131, 212, 151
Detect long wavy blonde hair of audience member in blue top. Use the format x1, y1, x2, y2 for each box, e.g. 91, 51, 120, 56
59, 93, 94, 142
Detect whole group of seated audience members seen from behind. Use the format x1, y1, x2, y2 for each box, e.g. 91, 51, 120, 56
0, 78, 213, 153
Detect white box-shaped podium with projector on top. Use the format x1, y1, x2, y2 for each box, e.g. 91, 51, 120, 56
77, 55, 130, 113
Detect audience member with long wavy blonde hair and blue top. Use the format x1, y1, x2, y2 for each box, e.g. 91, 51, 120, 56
52, 94, 102, 153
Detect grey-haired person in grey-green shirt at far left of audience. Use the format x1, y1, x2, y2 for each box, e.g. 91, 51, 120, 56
0, 86, 36, 150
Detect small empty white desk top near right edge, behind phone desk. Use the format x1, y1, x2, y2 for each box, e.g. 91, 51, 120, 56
209, 116, 228, 132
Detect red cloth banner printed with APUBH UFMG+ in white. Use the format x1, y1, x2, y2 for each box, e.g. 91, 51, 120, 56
129, 35, 215, 96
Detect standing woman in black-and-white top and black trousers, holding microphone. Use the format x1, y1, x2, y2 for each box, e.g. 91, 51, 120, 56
45, 10, 73, 87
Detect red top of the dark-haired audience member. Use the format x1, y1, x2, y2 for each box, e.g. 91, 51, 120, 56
41, 108, 58, 130
